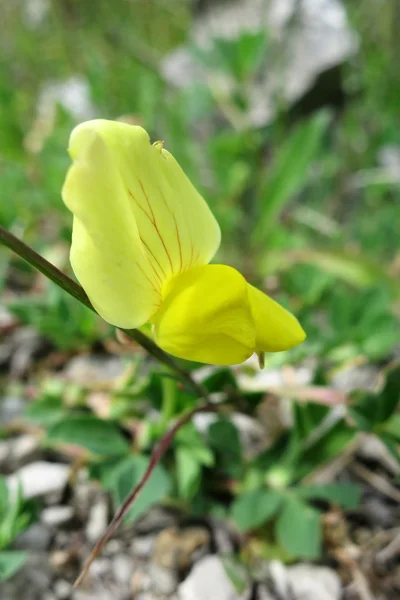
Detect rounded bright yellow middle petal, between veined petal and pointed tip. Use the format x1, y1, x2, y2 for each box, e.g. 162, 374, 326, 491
153, 265, 256, 365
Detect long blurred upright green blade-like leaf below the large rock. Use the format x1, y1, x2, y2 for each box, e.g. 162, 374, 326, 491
255, 111, 331, 240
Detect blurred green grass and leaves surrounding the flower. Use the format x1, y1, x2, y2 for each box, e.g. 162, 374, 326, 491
0, 0, 400, 564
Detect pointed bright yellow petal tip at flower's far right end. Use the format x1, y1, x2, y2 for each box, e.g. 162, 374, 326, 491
247, 284, 306, 353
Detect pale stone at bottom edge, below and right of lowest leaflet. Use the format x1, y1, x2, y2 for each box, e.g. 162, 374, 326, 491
287, 564, 341, 600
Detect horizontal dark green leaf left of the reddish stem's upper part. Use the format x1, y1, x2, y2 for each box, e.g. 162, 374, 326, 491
46, 415, 129, 456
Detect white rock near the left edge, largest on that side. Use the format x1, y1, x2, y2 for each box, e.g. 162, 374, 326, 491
7, 460, 69, 498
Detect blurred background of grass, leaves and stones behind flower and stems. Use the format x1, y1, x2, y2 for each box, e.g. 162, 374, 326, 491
0, 0, 400, 600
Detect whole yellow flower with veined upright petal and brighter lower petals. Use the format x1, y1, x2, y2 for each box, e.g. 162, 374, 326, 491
63, 120, 305, 365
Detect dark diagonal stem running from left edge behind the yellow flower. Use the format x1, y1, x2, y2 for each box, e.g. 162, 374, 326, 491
0, 226, 207, 398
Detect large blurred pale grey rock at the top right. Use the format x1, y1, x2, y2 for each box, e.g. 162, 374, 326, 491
163, 0, 358, 126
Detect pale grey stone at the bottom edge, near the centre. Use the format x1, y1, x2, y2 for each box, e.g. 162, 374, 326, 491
178, 555, 247, 600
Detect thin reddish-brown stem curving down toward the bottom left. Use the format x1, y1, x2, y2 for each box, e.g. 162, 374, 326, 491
74, 402, 218, 588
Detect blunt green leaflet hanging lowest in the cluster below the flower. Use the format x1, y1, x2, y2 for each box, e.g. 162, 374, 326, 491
276, 498, 321, 559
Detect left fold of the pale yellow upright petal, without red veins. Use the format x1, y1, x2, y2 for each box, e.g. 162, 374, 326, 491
63, 125, 161, 328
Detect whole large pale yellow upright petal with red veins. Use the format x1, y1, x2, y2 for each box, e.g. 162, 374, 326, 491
63, 120, 220, 327
